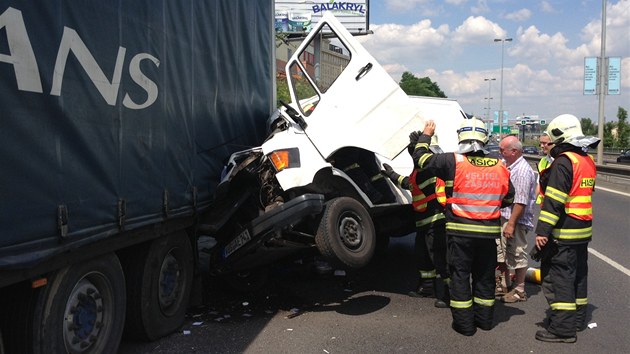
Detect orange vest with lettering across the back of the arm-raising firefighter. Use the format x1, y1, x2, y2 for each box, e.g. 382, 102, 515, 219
446, 154, 510, 220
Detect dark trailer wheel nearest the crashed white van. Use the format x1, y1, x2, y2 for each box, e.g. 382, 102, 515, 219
123, 231, 194, 340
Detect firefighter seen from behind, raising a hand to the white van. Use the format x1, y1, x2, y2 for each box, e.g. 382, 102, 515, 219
413, 117, 514, 336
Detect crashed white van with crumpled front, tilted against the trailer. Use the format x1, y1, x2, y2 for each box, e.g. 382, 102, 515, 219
202, 14, 465, 272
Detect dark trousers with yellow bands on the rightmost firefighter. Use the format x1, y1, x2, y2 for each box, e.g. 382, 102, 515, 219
540, 243, 588, 337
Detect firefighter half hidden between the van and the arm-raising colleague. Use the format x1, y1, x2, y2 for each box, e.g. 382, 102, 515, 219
381, 132, 450, 308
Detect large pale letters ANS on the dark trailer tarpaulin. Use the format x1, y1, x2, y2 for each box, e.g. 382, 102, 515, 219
0, 7, 160, 109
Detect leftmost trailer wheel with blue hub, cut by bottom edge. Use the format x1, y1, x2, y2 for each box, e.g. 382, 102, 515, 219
32, 254, 125, 353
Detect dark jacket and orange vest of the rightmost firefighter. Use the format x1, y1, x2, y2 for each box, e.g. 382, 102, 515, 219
536, 150, 597, 243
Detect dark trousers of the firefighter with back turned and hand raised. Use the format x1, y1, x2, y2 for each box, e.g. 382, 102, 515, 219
447, 234, 497, 335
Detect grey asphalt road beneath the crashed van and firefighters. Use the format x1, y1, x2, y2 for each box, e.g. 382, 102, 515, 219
120, 185, 630, 354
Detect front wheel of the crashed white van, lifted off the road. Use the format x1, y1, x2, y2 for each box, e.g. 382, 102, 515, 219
315, 197, 376, 268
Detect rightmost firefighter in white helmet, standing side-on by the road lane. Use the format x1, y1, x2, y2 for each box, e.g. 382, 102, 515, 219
536, 114, 600, 343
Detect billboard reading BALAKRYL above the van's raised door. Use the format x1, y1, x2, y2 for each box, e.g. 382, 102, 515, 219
275, 0, 369, 36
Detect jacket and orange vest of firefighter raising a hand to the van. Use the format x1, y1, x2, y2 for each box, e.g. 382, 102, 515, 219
413, 134, 514, 238
